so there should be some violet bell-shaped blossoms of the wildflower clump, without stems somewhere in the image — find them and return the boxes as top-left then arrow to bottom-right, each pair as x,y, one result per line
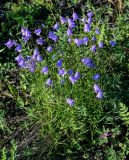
5,12 -> 116,106
